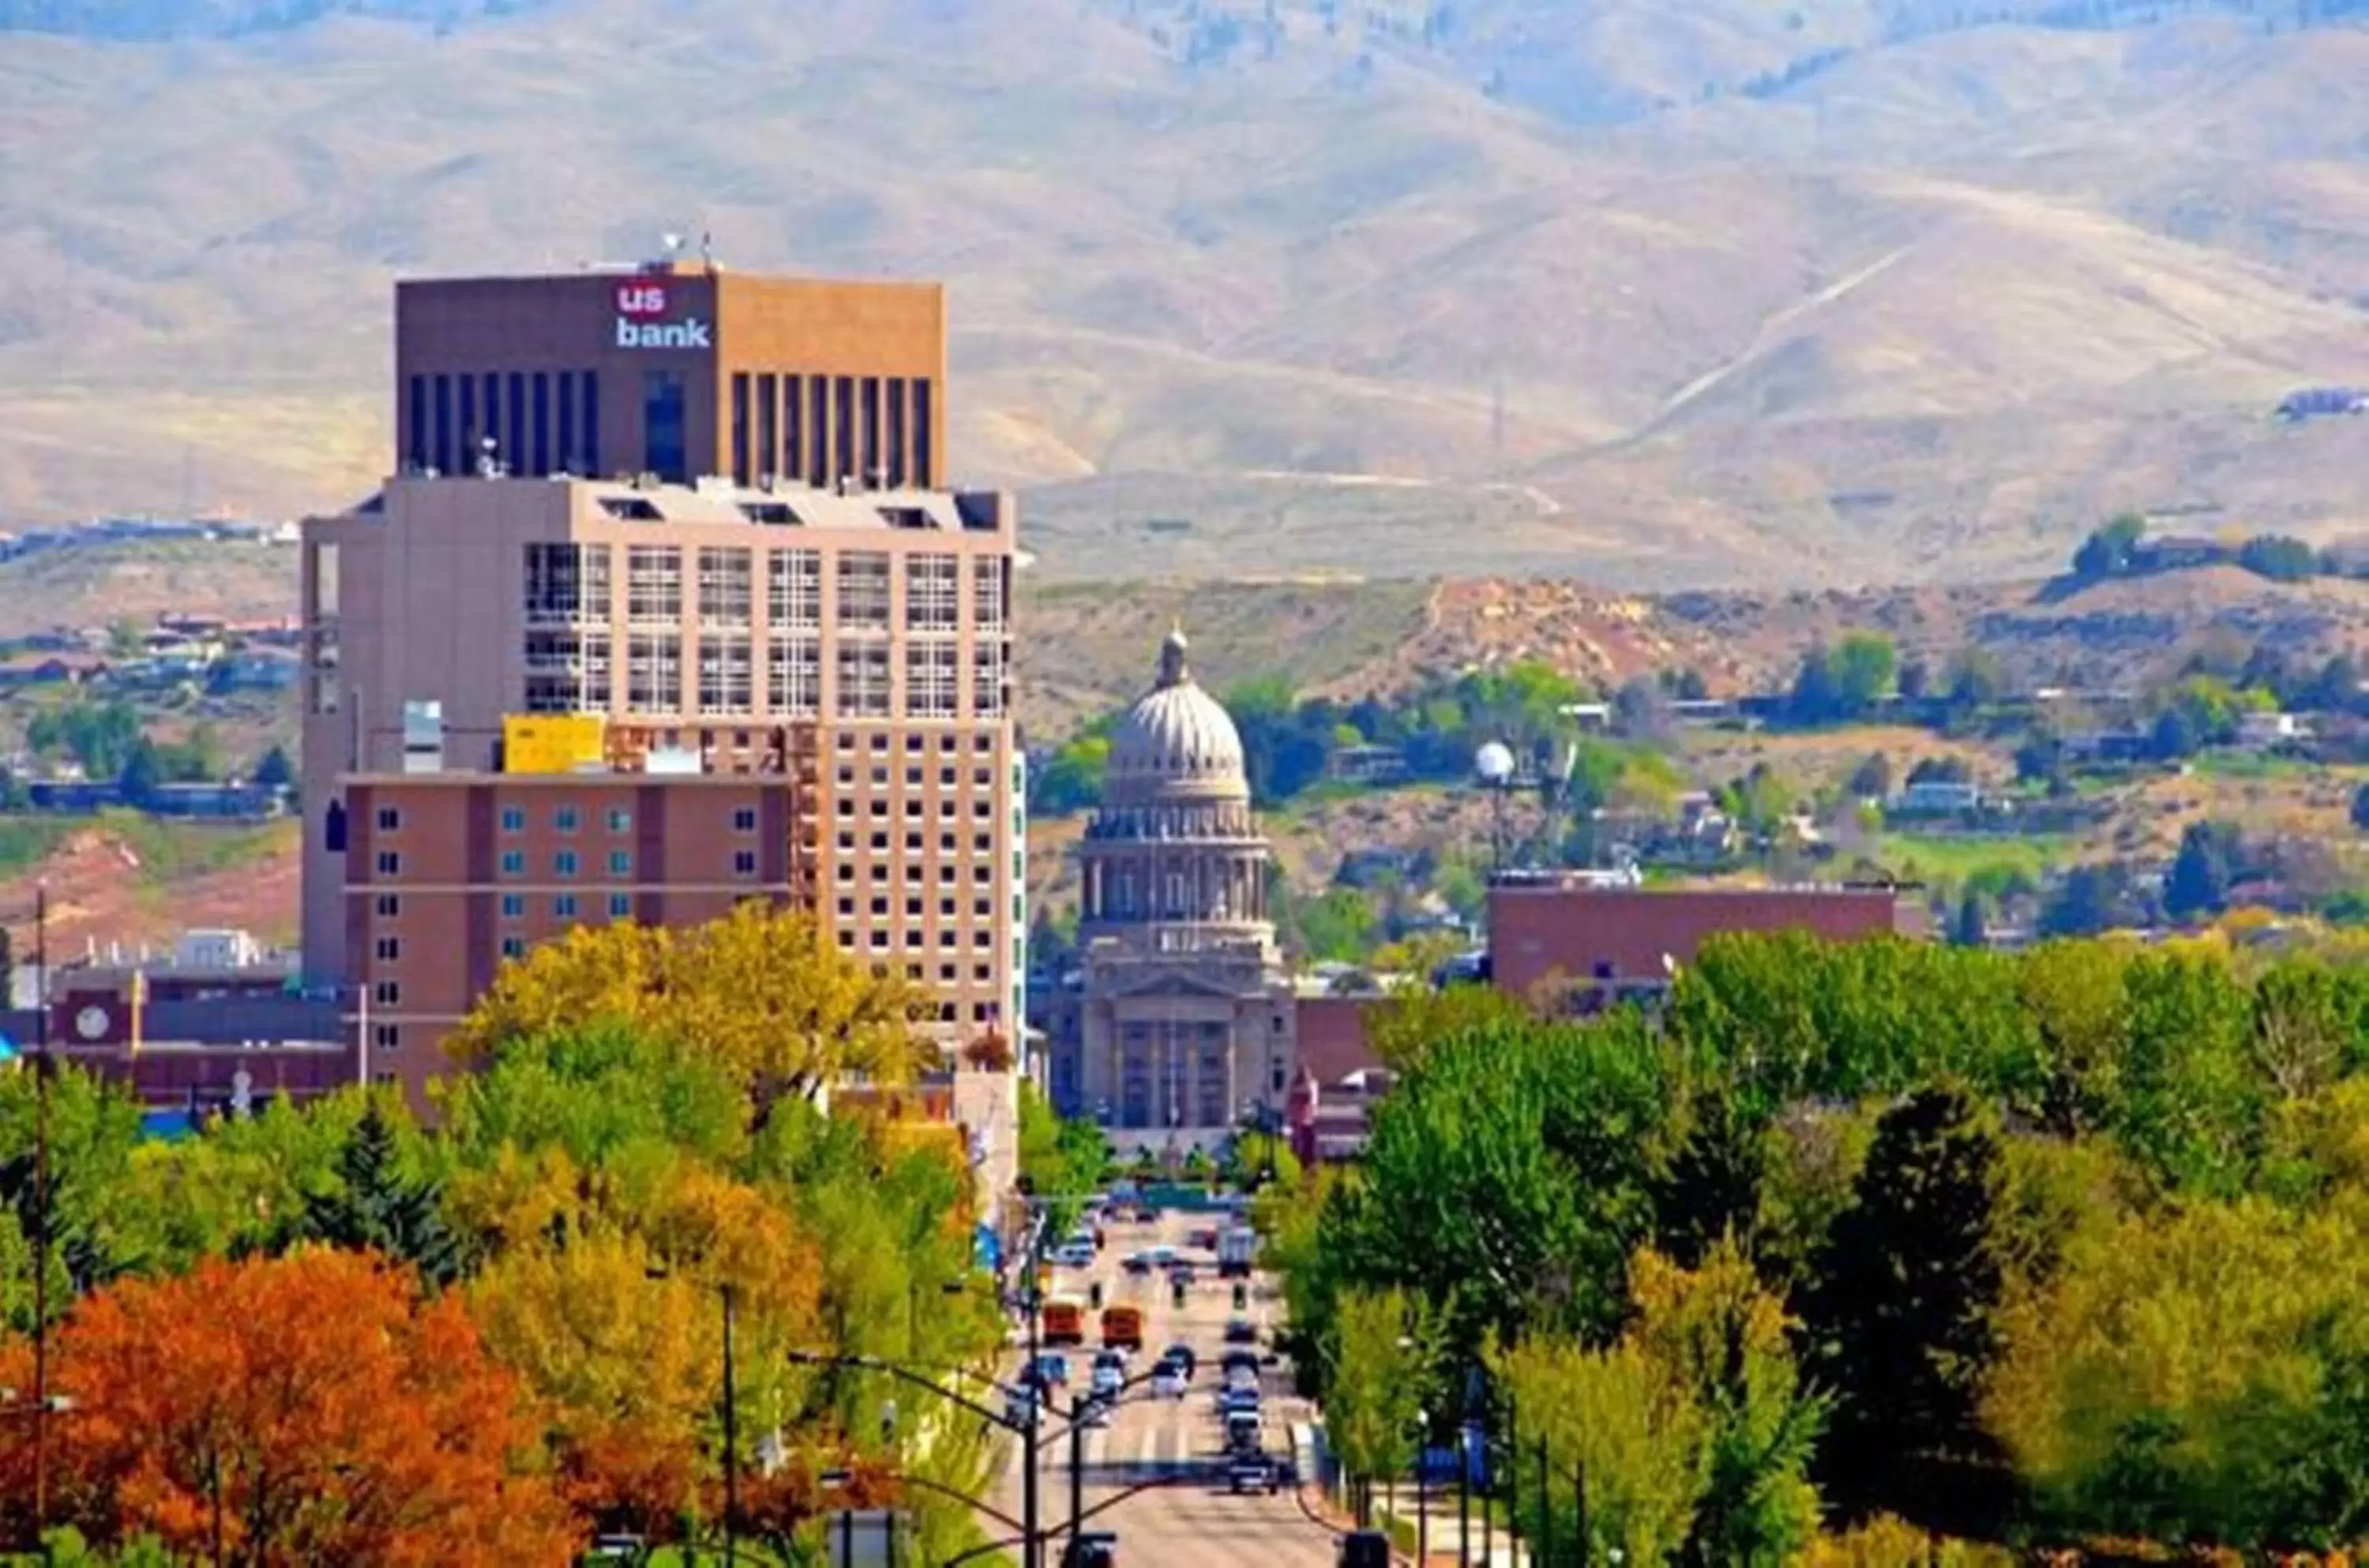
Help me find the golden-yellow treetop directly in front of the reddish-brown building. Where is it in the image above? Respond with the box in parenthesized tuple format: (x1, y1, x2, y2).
(450, 902, 926, 1116)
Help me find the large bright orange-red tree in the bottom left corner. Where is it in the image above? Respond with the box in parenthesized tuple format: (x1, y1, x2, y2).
(0, 1248, 578, 1568)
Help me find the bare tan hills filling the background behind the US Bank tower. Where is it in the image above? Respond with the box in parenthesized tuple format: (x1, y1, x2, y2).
(0, 0, 2369, 587)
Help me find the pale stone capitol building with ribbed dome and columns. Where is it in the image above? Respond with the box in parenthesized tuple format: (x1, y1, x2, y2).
(1042, 630, 1293, 1149)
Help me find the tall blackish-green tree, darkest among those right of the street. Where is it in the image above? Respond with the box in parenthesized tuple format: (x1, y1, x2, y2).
(1803, 1090, 2004, 1528)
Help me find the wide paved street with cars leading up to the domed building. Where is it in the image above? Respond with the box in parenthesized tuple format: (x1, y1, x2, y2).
(995, 1213, 1334, 1568)
